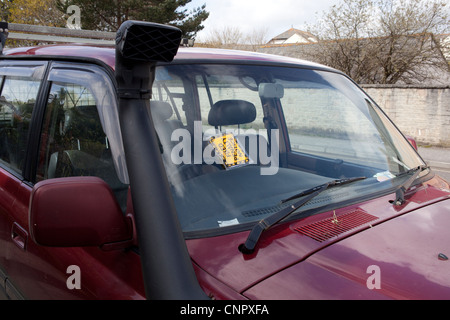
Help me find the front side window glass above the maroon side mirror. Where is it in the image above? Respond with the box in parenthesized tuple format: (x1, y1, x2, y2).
(37, 69, 128, 210)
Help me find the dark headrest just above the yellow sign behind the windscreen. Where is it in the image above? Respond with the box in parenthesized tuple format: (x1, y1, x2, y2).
(208, 100, 256, 127)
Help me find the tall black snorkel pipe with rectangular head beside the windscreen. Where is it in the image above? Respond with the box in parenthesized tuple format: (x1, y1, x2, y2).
(115, 21, 208, 300)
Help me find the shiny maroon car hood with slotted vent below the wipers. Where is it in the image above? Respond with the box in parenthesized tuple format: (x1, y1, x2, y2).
(188, 181, 450, 299)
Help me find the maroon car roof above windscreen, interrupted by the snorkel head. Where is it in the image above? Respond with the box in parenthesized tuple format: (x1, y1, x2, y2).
(4, 44, 335, 71)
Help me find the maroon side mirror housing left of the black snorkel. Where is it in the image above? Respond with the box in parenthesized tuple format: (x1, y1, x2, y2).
(29, 177, 133, 249)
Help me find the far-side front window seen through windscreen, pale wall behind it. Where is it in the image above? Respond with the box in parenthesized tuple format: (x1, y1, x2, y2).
(279, 81, 385, 163)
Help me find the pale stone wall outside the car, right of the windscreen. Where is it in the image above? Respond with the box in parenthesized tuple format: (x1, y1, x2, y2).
(361, 85, 450, 147)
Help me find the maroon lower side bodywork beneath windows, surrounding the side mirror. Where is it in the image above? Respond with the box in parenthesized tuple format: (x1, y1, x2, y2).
(0, 169, 145, 299)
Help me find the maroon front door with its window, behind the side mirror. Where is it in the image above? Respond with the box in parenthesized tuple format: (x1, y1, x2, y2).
(0, 63, 143, 299)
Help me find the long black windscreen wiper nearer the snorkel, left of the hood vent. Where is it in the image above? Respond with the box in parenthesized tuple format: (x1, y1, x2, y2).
(239, 177, 366, 254)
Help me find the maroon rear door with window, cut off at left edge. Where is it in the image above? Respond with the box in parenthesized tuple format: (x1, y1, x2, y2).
(0, 60, 47, 298)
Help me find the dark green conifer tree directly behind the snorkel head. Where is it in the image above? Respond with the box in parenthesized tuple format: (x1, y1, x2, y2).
(59, 0, 209, 38)
